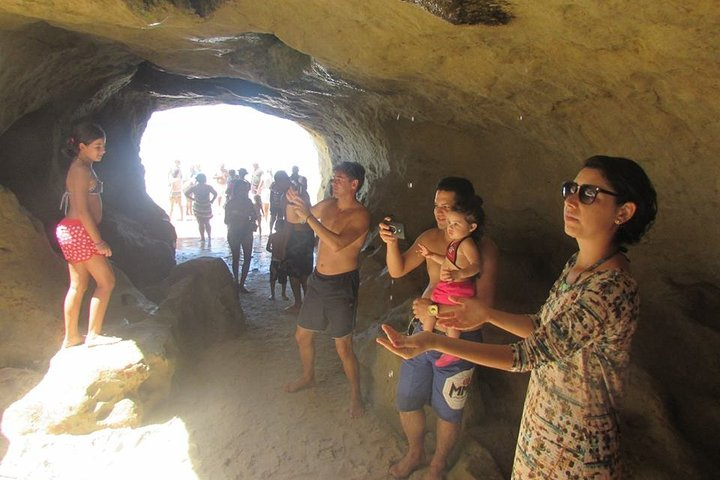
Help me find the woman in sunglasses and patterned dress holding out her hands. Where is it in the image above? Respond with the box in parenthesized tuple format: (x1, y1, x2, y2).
(378, 156, 657, 479)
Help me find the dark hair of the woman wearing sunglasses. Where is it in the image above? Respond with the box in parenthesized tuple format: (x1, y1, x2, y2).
(584, 155, 657, 245)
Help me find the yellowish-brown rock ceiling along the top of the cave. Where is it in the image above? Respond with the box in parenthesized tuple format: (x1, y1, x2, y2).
(0, 0, 720, 140)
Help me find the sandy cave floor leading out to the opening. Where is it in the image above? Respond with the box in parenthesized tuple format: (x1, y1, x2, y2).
(147, 218, 414, 479)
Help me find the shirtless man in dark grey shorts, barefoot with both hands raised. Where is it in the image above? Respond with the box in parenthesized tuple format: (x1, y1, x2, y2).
(285, 162, 370, 418)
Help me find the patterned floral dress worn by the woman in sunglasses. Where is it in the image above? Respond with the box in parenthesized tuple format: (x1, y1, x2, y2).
(511, 254, 640, 479)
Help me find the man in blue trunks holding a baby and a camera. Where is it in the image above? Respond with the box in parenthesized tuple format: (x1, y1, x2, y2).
(380, 177, 498, 480)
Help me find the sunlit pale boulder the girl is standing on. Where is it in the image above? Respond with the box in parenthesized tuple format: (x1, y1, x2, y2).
(2, 321, 174, 441)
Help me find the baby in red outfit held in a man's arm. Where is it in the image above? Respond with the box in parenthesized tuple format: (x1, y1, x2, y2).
(418, 195, 485, 367)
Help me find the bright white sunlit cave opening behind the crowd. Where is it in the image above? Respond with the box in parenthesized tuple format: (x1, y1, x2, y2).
(140, 104, 323, 248)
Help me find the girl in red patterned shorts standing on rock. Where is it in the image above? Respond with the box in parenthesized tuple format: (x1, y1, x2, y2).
(55, 123, 120, 348)
